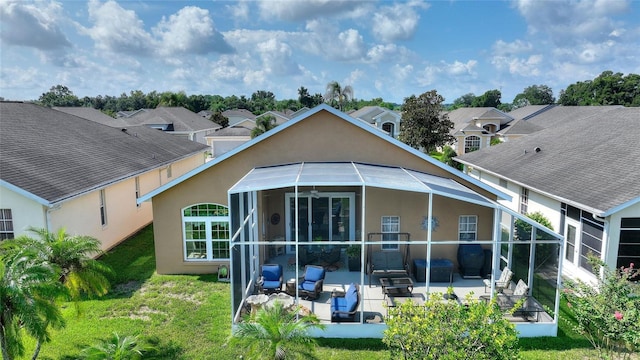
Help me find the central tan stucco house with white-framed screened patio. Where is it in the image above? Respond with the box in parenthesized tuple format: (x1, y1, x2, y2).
(138, 104, 562, 337)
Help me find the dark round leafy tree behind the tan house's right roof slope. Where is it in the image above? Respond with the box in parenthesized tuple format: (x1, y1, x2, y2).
(399, 90, 455, 152)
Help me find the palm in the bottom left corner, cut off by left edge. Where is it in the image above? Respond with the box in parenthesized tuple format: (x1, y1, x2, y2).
(0, 248, 65, 360)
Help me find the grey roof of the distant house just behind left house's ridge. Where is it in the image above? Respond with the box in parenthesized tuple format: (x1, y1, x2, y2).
(123, 106, 221, 132)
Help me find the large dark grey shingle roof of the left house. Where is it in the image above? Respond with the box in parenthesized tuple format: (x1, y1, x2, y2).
(0, 102, 208, 203)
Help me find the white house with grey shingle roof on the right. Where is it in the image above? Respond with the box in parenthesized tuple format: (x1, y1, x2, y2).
(456, 106, 640, 280)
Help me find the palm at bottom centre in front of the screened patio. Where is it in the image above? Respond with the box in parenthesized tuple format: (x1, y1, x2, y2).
(232, 301, 325, 360)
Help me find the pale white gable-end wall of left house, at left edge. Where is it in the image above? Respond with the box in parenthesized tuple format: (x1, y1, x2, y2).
(0, 185, 47, 237)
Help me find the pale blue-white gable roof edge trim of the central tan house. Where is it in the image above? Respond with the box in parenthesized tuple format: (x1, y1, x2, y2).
(138, 104, 511, 202)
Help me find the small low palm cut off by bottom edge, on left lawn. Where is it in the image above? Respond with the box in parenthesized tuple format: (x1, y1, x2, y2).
(82, 332, 150, 360)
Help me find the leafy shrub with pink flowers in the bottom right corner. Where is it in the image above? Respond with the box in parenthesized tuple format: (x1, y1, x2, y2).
(562, 257, 640, 359)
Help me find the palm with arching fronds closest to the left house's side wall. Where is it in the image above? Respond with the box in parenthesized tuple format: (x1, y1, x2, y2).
(3, 227, 113, 303)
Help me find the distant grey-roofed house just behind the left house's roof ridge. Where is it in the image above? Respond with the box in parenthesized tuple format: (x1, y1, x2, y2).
(121, 106, 222, 144)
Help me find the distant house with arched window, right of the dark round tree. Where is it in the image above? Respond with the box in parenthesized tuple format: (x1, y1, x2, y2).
(448, 107, 513, 155)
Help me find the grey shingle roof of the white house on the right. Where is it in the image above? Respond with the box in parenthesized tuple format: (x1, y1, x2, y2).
(455, 106, 640, 216)
